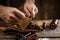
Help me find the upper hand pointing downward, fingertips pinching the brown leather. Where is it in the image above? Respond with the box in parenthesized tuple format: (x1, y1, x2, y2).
(24, 2, 38, 17)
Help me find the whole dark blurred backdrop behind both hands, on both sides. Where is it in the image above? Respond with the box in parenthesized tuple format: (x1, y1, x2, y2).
(0, 0, 60, 19)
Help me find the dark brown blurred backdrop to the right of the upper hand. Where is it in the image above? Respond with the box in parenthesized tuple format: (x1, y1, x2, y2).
(35, 0, 60, 19)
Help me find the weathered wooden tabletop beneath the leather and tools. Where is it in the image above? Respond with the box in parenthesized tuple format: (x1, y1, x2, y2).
(0, 20, 60, 40)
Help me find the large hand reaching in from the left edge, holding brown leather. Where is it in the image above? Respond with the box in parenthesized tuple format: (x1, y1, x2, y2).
(0, 6, 25, 23)
